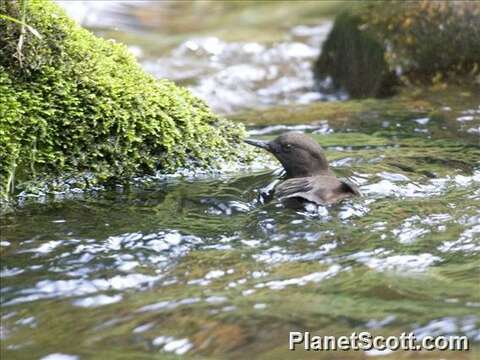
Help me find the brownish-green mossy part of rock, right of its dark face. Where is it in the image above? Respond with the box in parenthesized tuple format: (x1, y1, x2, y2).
(360, 0, 480, 82)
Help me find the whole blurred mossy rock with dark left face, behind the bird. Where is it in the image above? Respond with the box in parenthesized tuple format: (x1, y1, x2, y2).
(314, 0, 480, 98)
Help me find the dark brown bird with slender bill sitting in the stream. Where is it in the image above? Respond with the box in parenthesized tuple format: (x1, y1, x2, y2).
(245, 132, 360, 205)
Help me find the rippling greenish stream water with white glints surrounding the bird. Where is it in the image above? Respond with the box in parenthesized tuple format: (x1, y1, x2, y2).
(0, 1, 480, 360)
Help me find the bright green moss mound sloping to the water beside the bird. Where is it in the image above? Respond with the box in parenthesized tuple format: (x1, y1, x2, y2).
(0, 0, 248, 198)
